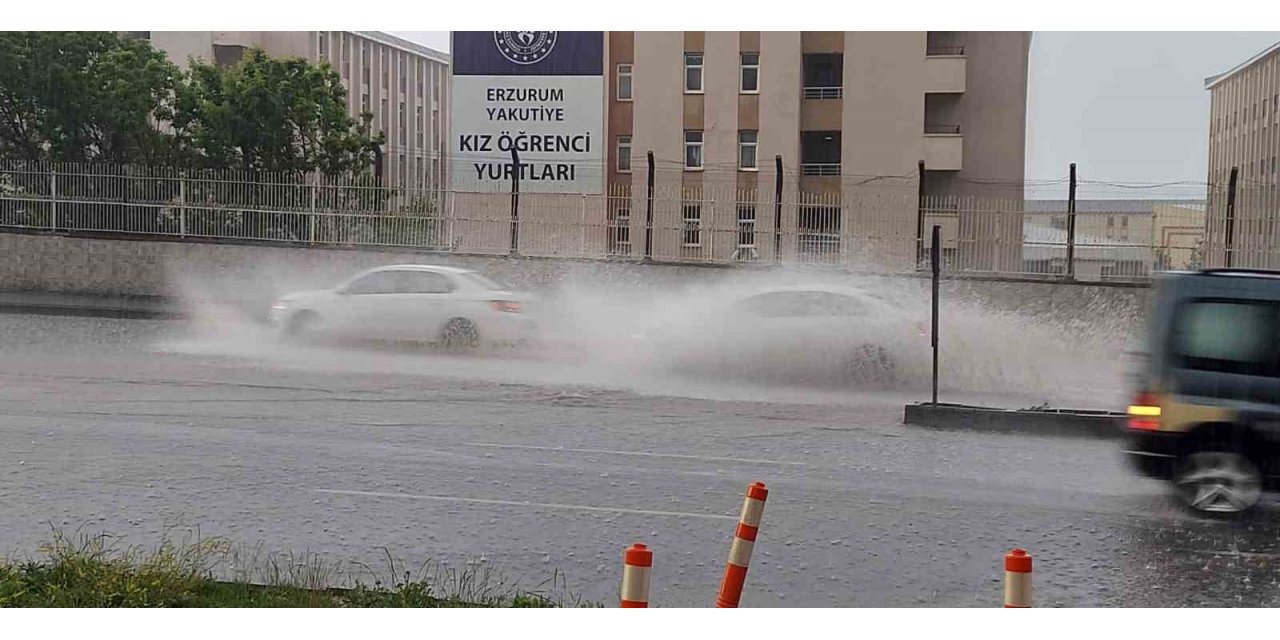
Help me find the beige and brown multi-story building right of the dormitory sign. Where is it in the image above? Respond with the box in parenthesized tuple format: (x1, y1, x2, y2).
(605, 31, 1030, 270)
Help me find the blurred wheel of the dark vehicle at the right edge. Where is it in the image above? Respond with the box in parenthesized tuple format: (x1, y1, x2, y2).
(1174, 451, 1262, 516)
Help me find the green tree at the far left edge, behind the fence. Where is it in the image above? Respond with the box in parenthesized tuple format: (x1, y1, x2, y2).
(0, 31, 180, 164)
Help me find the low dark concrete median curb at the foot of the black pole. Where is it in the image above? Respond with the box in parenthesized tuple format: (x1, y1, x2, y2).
(902, 402, 1124, 439)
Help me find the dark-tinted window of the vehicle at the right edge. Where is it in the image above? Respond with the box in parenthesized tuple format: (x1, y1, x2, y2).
(1172, 300, 1280, 376)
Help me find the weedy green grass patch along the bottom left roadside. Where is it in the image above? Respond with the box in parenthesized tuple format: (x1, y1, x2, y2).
(0, 529, 595, 608)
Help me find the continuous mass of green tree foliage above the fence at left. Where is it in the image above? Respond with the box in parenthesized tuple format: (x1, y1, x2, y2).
(0, 32, 383, 175)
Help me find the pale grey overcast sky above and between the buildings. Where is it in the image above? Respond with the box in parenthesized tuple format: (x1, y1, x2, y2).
(393, 31, 1280, 197)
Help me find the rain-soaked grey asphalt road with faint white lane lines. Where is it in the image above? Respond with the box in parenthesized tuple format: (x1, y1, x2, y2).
(0, 315, 1280, 607)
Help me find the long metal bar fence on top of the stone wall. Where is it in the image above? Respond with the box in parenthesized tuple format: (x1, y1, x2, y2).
(0, 163, 1212, 282)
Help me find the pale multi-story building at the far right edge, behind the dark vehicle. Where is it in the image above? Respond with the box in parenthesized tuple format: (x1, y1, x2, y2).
(1204, 42, 1280, 268)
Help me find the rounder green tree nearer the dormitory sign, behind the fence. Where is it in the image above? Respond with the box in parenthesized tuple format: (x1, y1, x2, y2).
(174, 47, 383, 175)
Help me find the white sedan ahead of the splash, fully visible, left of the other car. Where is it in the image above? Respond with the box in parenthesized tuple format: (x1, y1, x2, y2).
(271, 265, 535, 349)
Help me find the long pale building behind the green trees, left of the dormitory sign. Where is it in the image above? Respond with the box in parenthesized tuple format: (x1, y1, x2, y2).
(125, 31, 449, 188)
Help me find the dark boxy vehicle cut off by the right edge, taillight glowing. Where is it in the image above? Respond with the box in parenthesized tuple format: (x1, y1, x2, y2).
(1125, 270, 1280, 515)
